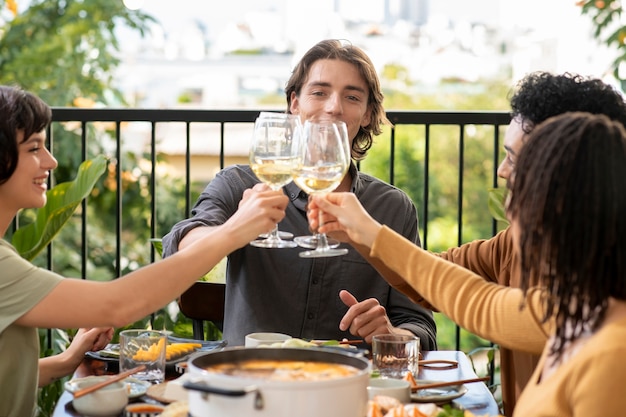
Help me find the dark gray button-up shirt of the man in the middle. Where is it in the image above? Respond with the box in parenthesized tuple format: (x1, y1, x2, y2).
(163, 165, 437, 350)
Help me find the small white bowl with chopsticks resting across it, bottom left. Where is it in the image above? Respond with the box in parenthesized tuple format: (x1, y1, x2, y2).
(65, 376, 128, 417)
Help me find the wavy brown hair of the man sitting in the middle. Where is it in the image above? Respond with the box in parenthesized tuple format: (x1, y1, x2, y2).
(285, 39, 391, 161)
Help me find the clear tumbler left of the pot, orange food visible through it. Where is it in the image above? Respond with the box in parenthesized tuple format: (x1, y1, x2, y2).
(120, 329, 167, 384)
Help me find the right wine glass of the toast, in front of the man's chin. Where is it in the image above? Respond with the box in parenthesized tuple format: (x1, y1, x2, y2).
(293, 120, 350, 258)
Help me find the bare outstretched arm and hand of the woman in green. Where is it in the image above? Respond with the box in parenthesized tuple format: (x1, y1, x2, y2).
(17, 191, 289, 328)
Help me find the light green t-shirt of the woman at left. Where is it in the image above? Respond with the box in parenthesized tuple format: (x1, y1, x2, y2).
(0, 239, 63, 417)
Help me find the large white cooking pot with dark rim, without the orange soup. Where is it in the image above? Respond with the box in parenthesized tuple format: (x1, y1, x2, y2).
(183, 348, 370, 417)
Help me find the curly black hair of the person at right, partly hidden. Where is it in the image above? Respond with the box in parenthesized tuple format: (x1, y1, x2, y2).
(509, 71, 626, 133)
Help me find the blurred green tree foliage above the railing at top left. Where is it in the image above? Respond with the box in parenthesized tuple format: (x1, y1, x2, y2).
(0, 0, 154, 106)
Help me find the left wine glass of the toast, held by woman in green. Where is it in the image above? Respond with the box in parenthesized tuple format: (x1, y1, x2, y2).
(250, 112, 301, 248)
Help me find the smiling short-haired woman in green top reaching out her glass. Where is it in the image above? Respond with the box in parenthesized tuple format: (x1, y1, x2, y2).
(0, 86, 288, 417)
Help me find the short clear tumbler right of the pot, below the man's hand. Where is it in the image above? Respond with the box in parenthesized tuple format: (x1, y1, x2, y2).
(372, 334, 420, 378)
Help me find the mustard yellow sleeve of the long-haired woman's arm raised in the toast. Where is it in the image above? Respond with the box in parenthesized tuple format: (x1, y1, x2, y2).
(370, 227, 552, 354)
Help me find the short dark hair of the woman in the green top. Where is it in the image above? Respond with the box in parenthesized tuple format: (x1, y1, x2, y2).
(0, 85, 52, 184)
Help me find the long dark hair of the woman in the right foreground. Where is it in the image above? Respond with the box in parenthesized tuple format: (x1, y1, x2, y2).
(507, 113, 626, 359)
